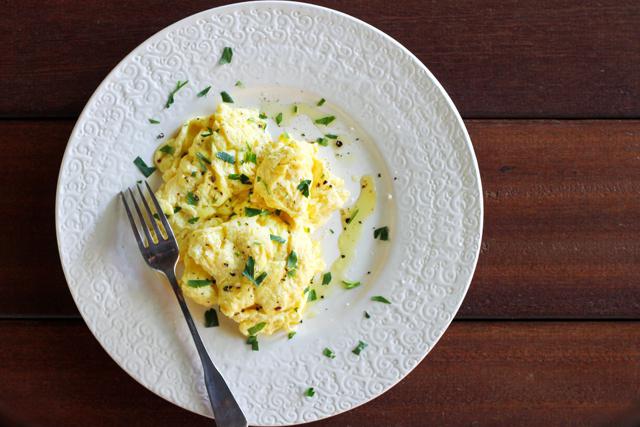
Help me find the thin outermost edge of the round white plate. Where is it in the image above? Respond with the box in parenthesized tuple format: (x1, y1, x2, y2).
(54, 0, 484, 426)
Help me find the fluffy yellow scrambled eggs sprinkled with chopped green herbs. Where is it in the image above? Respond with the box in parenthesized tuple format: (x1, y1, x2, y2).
(154, 104, 348, 335)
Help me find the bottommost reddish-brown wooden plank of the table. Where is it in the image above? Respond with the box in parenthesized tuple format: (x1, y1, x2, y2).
(0, 321, 640, 427)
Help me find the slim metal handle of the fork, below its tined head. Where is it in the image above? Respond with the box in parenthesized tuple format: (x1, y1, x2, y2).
(164, 270, 247, 427)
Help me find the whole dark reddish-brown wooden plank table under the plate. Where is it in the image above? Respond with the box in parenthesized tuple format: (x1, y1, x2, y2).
(0, 0, 640, 427)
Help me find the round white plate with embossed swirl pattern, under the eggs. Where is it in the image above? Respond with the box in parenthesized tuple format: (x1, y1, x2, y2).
(56, 2, 482, 425)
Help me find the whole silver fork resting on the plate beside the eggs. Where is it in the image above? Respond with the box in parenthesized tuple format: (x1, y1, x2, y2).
(120, 181, 247, 427)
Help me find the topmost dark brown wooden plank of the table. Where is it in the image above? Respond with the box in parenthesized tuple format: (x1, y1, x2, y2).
(0, 0, 640, 118)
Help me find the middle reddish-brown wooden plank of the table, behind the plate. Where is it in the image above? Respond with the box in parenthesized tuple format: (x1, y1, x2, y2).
(0, 120, 640, 318)
